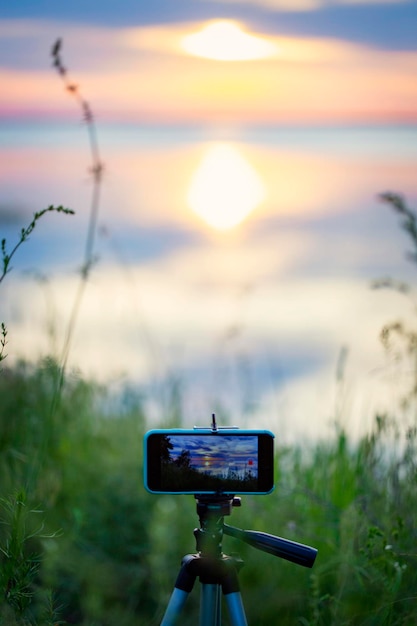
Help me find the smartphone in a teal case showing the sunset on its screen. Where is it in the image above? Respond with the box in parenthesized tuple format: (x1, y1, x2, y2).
(144, 428, 274, 495)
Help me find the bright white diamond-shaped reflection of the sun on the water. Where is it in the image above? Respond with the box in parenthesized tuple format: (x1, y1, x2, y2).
(187, 143, 265, 231)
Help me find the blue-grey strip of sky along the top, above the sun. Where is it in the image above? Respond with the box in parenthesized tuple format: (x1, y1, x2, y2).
(0, 0, 417, 50)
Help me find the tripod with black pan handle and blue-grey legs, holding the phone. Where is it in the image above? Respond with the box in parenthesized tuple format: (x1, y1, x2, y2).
(161, 495, 317, 626)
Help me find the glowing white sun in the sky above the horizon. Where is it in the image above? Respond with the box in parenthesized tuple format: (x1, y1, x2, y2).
(181, 20, 276, 61)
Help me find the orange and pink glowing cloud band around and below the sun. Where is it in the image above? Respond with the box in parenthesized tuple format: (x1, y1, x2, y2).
(0, 18, 417, 123)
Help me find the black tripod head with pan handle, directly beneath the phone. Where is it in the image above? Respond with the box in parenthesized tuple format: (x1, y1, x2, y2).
(194, 495, 317, 567)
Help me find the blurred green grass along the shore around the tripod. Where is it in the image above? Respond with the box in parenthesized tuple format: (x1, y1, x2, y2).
(0, 360, 417, 626)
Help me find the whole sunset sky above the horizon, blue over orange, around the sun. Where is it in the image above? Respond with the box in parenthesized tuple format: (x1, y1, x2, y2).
(0, 0, 417, 124)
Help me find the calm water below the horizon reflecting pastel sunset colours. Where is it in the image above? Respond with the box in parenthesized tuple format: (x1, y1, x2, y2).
(0, 123, 417, 438)
